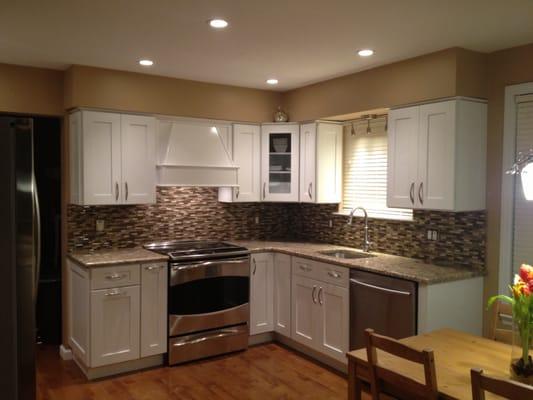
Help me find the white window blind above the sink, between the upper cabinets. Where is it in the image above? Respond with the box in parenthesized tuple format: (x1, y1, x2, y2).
(342, 118, 413, 220)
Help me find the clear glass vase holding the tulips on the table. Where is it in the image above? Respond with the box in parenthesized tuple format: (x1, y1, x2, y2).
(510, 311, 533, 385)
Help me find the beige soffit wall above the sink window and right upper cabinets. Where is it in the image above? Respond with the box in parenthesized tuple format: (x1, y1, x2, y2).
(283, 48, 485, 121)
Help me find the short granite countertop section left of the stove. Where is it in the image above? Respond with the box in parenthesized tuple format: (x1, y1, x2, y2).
(68, 247, 168, 267)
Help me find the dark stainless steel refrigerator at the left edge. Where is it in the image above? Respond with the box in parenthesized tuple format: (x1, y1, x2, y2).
(0, 116, 40, 400)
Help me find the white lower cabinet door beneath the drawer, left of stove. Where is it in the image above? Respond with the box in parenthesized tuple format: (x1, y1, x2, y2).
(90, 286, 141, 367)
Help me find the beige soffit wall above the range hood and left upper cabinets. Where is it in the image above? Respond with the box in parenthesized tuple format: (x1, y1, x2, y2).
(65, 66, 281, 122)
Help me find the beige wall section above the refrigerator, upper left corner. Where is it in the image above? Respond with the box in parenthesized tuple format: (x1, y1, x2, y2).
(0, 64, 63, 115)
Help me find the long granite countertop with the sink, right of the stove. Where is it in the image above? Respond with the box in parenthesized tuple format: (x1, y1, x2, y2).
(228, 241, 485, 285)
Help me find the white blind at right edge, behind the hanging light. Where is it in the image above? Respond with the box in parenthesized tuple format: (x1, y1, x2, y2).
(513, 95, 533, 271)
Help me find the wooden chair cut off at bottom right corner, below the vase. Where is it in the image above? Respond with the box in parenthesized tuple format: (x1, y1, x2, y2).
(470, 368, 533, 400)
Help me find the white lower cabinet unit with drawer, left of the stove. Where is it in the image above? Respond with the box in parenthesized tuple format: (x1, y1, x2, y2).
(68, 260, 167, 378)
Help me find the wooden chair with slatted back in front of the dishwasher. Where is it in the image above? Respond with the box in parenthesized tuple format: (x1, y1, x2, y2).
(365, 329, 439, 400)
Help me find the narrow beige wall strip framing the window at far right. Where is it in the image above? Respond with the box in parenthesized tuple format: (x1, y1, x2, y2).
(485, 44, 533, 334)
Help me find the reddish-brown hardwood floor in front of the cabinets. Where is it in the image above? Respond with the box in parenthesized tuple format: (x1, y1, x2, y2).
(37, 343, 354, 400)
